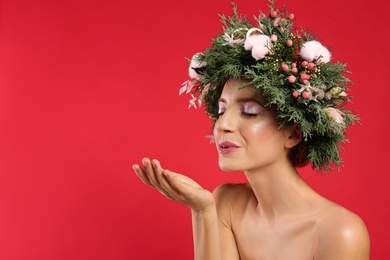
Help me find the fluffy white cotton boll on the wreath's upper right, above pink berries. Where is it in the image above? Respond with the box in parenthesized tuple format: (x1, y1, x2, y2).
(300, 41, 331, 63)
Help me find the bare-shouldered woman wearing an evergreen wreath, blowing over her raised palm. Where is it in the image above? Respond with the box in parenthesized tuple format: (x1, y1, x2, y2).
(133, 2, 369, 260)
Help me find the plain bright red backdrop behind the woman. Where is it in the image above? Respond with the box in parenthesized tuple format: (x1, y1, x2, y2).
(0, 0, 390, 259)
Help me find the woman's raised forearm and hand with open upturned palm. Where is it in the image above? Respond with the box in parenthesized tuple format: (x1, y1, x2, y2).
(133, 158, 222, 260)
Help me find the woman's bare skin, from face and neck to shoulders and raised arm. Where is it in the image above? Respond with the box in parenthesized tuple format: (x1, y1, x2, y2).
(133, 80, 370, 260)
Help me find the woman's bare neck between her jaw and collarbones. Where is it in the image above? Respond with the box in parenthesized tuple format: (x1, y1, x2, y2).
(245, 164, 317, 220)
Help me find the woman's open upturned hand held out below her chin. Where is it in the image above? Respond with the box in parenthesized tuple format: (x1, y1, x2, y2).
(133, 158, 215, 212)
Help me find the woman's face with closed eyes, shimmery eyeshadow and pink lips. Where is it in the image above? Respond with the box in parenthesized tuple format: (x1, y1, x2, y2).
(214, 80, 288, 172)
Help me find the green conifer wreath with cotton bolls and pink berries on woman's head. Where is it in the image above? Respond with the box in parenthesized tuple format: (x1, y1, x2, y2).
(179, 0, 358, 172)
